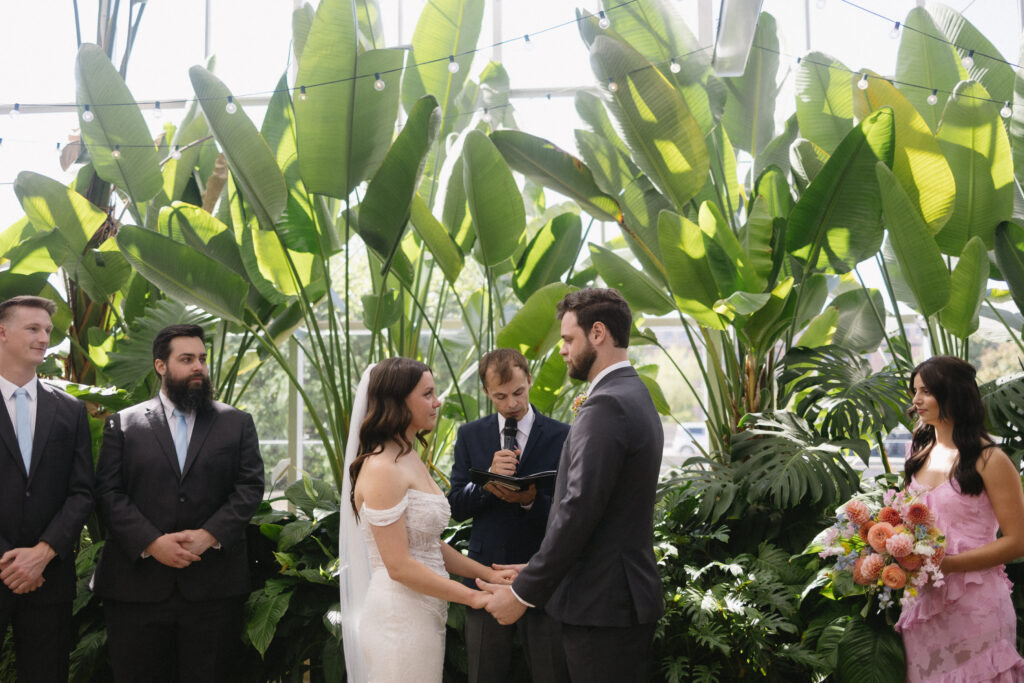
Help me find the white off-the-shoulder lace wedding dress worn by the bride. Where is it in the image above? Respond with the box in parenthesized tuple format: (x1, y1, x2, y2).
(358, 488, 452, 683)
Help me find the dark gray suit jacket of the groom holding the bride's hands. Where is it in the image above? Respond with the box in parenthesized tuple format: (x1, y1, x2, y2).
(512, 368, 665, 627)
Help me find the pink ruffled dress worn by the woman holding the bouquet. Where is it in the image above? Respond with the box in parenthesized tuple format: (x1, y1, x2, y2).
(896, 481, 1024, 683)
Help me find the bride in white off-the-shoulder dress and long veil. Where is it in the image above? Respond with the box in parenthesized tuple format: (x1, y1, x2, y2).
(340, 357, 515, 683)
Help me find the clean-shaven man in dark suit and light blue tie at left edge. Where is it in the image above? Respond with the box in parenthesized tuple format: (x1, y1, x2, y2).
(0, 296, 92, 683)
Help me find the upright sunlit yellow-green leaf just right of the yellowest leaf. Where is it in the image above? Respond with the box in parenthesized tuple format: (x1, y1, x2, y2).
(936, 81, 1014, 256)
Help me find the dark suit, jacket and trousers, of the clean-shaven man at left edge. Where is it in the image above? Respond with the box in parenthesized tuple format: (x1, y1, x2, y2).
(0, 382, 93, 681)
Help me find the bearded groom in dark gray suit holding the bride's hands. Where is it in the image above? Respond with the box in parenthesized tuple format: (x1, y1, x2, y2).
(478, 289, 665, 683)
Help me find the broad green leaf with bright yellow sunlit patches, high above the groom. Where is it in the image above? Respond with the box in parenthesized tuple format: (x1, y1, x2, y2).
(590, 36, 710, 210)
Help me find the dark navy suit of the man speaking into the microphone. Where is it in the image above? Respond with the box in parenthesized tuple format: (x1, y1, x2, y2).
(447, 408, 569, 683)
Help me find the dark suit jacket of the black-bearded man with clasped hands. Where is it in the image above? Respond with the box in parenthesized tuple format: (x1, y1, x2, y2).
(95, 396, 263, 602)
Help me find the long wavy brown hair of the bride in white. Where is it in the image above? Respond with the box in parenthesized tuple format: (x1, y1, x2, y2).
(348, 356, 430, 514)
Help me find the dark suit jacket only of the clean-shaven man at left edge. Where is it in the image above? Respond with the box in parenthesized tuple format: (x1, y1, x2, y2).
(0, 382, 92, 603)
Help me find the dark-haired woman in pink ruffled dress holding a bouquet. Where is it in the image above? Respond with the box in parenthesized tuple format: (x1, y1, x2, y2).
(896, 356, 1024, 683)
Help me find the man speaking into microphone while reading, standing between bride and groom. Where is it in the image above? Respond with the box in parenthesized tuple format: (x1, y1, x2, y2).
(447, 348, 569, 683)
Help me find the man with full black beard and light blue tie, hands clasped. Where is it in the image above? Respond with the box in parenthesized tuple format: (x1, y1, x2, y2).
(95, 325, 263, 683)
